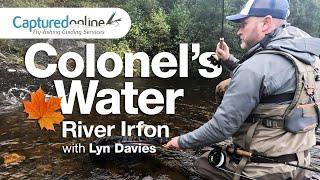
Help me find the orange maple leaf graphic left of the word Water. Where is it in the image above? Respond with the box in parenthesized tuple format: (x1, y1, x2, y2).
(23, 87, 64, 130)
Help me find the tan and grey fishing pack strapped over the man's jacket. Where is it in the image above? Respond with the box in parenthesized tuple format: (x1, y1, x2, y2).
(248, 50, 320, 133)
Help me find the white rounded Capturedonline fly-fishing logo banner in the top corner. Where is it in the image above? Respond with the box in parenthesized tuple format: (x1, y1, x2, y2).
(0, 8, 131, 39)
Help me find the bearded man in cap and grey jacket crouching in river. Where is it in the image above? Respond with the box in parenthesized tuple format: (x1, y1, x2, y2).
(165, 0, 320, 179)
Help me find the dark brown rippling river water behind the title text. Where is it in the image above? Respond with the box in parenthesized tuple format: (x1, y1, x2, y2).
(0, 60, 320, 180)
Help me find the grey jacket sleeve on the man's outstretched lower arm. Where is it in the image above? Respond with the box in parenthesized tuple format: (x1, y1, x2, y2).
(178, 65, 264, 148)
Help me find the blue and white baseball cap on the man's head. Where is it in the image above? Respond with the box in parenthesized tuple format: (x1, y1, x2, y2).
(226, 0, 290, 23)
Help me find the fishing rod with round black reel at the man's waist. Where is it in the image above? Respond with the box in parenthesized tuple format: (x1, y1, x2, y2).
(208, 145, 320, 173)
